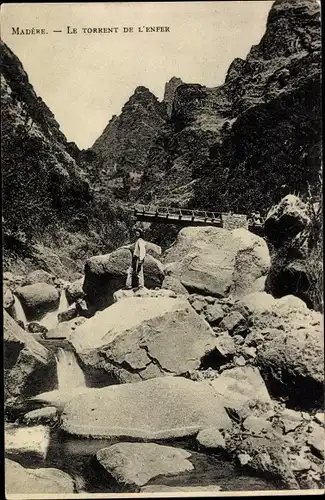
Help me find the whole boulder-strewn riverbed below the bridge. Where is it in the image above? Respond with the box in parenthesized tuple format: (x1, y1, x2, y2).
(4, 217, 325, 494)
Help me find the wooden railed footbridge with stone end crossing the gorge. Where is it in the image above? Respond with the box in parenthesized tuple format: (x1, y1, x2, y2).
(133, 205, 264, 233)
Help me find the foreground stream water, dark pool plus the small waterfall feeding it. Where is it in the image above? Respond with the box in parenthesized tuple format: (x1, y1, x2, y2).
(5, 324, 277, 493)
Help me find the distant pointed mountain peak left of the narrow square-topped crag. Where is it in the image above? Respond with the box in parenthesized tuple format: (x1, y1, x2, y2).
(92, 86, 167, 198)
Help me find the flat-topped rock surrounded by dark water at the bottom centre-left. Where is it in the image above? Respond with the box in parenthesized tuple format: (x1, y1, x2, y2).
(96, 443, 194, 488)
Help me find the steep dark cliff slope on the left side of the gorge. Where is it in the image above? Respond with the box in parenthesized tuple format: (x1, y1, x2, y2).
(0, 43, 127, 278)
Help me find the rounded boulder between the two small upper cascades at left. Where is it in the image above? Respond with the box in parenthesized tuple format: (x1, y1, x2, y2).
(15, 283, 60, 320)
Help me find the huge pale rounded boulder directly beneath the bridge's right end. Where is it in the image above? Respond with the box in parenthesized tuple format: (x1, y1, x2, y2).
(164, 226, 270, 297)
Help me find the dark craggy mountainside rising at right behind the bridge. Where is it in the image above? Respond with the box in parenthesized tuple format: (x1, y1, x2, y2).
(141, 0, 321, 213)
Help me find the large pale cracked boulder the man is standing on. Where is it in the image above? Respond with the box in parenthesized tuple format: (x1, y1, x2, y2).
(70, 290, 223, 382)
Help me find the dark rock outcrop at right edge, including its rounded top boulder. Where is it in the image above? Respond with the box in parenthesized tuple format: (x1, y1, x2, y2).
(264, 195, 323, 312)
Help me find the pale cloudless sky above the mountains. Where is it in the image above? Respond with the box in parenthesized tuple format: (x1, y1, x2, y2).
(1, 0, 273, 149)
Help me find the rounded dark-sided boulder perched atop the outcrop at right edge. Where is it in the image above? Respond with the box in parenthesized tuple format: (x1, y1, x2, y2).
(264, 194, 310, 246)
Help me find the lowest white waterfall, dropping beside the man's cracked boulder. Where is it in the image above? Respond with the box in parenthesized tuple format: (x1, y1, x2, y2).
(55, 347, 87, 391)
